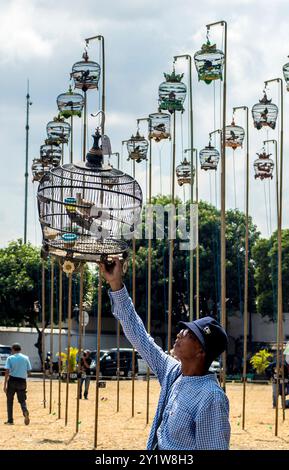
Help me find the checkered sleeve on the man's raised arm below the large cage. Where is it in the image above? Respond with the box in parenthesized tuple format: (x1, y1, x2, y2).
(109, 286, 178, 384)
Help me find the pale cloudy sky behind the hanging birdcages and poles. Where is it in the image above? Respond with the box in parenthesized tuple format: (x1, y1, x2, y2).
(0, 0, 289, 246)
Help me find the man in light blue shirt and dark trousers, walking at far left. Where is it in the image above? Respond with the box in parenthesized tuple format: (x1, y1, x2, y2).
(4, 343, 31, 425)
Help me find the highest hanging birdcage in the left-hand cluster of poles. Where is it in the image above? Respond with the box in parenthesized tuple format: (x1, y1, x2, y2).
(71, 50, 100, 92)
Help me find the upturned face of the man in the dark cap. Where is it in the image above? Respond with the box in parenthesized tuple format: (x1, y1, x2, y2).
(174, 329, 205, 361)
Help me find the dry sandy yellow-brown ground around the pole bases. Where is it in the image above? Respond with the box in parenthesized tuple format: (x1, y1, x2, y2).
(0, 379, 289, 450)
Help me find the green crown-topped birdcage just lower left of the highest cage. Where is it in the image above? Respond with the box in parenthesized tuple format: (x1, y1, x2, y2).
(159, 69, 187, 114)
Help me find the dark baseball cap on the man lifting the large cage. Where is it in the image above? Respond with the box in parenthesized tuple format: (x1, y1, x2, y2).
(179, 317, 228, 362)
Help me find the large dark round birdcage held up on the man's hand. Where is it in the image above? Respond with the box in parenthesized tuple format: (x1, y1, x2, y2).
(37, 130, 142, 262)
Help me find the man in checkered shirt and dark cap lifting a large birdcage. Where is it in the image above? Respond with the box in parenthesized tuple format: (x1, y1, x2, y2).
(101, 258, 230, 450)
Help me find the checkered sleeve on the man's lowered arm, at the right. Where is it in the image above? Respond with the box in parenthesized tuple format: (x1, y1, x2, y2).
(196, 396, 231, 450)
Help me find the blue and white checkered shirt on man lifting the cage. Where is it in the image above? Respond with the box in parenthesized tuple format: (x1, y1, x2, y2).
(109, 287, 230, 450)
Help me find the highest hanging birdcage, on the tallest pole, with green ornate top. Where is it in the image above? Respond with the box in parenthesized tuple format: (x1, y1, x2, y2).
(194, 39, 225, 84)
